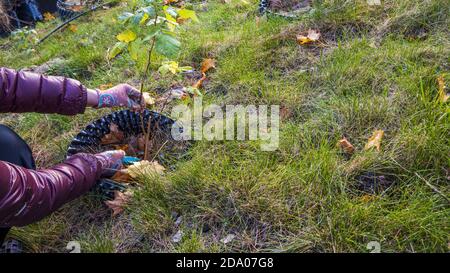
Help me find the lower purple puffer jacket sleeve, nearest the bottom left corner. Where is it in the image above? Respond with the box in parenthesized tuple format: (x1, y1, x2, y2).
(0, 154, 106, 227)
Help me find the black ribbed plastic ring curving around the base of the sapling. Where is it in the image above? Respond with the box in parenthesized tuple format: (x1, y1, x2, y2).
(67, 110, 182, 156)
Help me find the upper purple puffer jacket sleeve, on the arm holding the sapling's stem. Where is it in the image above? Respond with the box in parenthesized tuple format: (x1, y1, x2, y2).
(0, 68, 87, 115)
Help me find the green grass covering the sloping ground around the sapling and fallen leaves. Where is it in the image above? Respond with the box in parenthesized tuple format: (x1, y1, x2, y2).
(0, 0, 450, 252)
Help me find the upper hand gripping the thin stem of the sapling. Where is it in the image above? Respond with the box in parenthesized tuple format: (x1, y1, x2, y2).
(88, 84, 145, 110)
